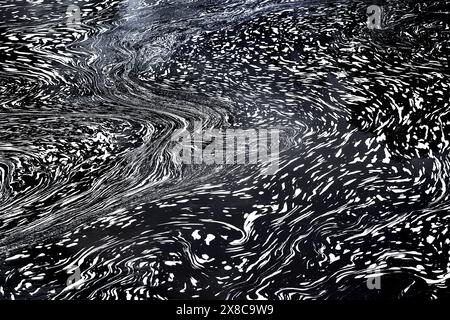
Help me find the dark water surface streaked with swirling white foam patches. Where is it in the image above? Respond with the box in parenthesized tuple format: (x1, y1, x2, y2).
(0, 0, 450, 299)
